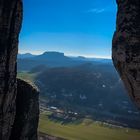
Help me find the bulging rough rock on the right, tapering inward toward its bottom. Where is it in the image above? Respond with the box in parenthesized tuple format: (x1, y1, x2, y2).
(112, 0, 140, 108)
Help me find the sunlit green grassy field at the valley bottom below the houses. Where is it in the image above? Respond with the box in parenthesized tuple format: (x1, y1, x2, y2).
(39, 114, 140, 140)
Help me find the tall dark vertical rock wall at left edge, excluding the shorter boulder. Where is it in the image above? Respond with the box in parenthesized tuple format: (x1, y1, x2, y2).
(0, 0, 22, 140)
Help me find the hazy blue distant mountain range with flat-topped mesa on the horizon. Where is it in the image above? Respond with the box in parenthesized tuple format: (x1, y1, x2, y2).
(18, 52, 111, 71)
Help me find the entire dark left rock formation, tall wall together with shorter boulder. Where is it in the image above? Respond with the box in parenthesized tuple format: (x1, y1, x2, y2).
(0, 0, 39, 140)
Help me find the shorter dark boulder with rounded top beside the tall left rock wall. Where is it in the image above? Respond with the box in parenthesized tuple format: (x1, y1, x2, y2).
(11, 79, 39, 140)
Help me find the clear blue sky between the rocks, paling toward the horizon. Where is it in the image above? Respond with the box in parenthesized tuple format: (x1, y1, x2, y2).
(19, 0, 116, 57)
